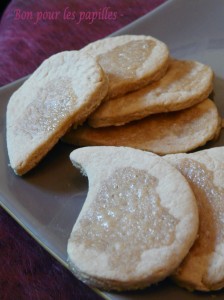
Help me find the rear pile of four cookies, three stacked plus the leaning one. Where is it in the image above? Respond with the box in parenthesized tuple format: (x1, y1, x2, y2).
(7, 35, 221, 175)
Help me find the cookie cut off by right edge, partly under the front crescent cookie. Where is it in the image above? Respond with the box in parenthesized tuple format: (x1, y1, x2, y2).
(166, 147, 224, 291)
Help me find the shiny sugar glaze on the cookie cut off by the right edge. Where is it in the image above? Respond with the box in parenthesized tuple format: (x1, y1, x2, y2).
(177, 158, 224, 255)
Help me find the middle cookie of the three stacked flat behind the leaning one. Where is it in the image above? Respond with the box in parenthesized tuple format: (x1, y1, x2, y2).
(89, 60, 213, 127)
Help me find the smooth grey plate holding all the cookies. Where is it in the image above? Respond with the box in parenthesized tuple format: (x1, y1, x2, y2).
(0, 0, 224, 300)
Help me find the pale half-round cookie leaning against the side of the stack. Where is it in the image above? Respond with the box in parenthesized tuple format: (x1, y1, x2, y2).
(7, 51, 108, 175)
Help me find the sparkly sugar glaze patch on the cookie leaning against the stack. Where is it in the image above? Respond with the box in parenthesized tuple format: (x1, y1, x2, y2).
(16, 79, 77, 139)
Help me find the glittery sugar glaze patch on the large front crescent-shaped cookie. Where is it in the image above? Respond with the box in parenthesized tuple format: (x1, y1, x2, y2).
(73, 167, 178, 274)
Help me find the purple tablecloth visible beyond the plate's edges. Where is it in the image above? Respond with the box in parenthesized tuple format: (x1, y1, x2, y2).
(0, 0, 164, 300)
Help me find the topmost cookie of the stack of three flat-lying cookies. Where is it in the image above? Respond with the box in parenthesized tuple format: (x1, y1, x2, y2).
(81, 35, 169, 99)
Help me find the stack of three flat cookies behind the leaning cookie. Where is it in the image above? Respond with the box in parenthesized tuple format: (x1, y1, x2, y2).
(63, 36, 221, 155)
